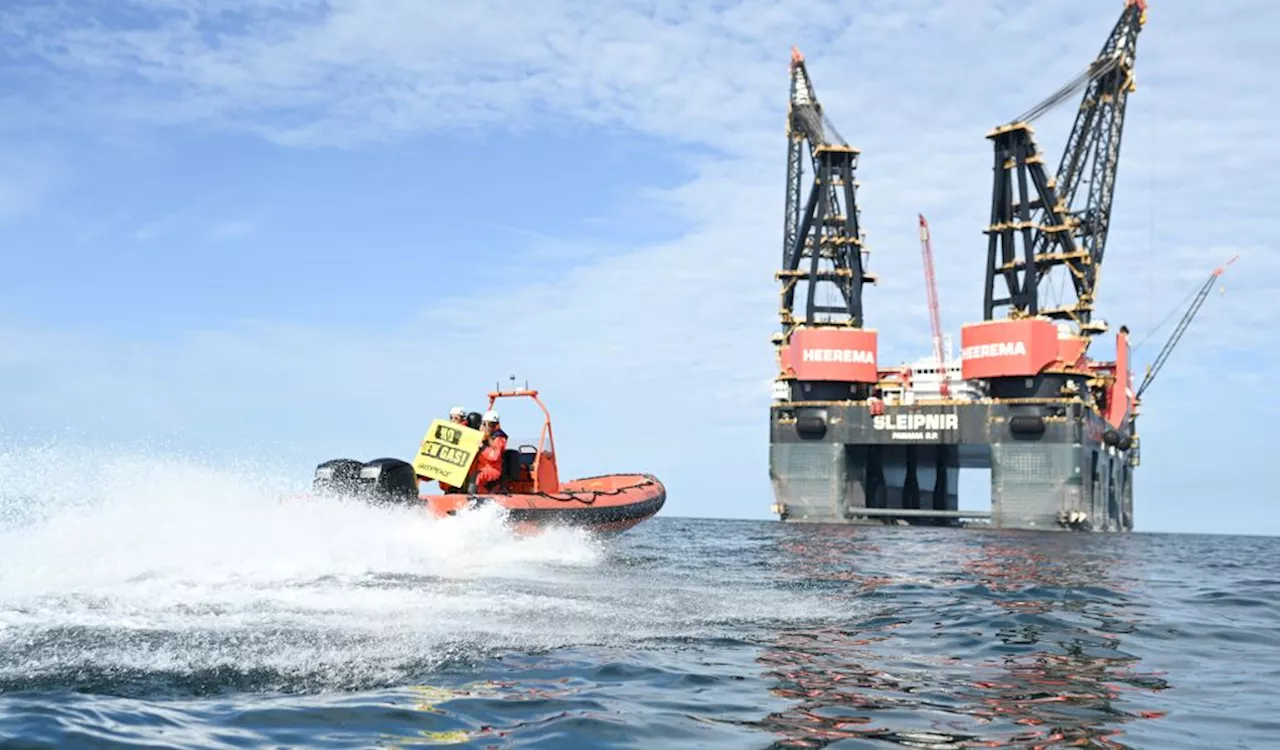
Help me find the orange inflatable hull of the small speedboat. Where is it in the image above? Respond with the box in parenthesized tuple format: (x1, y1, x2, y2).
(420, 474, 667, 534)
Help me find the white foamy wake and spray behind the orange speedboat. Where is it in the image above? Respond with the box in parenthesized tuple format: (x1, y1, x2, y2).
(0, 440, 605, 692)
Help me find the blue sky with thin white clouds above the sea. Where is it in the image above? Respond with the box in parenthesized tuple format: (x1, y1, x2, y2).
(0, 0, 1280, 534)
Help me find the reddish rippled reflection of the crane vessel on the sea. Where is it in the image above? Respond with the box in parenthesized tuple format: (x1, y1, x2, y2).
(758, 527, 1169, 749)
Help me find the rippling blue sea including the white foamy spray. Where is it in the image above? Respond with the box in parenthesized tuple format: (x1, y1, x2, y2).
(0, 451, 1280, 749)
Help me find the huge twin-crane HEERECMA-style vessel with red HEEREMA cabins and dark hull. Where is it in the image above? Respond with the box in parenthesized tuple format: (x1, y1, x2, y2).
(769, 0, 1234, 531)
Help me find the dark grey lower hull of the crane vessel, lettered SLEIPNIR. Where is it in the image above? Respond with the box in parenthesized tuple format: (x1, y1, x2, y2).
(769, 399, 1138, 531)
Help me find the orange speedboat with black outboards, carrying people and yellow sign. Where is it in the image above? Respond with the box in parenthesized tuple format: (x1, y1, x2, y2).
(312, 388, 667, 534)
